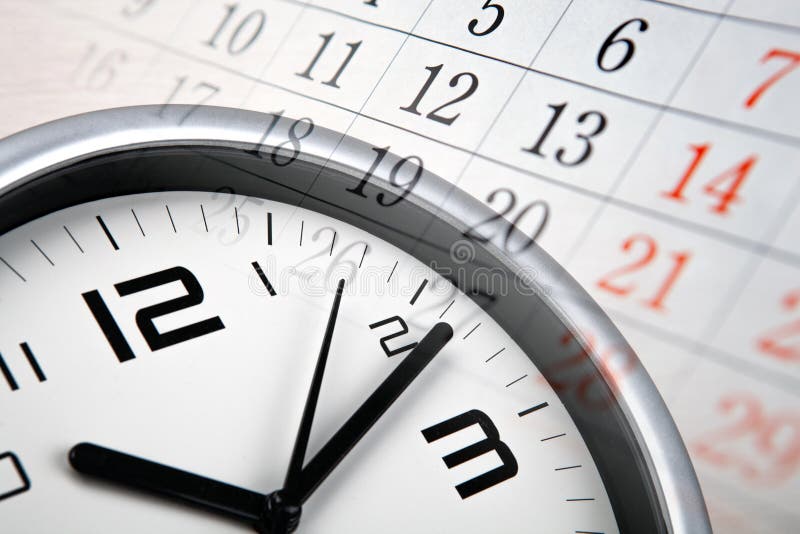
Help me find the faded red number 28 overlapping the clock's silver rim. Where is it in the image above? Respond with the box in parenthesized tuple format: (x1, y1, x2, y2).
(542, 331, 638, 410)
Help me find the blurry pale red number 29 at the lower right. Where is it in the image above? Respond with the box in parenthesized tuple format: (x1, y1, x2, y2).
(692, 394, 800, 484)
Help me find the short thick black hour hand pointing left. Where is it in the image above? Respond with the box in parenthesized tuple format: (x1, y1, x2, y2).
(69, 443, 267, 525)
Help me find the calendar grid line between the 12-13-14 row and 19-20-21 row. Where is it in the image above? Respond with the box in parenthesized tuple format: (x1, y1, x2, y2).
(45, 7, 800, 276)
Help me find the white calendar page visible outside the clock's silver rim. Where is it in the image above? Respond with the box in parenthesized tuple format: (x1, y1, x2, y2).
(0, 0, 800, 533)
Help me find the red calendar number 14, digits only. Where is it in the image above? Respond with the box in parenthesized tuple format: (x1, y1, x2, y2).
(661, 143, 758, 215)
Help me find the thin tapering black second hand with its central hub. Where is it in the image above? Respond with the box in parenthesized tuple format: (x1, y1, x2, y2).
(262, 279, 345, 534)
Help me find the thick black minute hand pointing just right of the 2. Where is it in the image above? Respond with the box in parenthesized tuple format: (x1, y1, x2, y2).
(297, 323, 453, 503)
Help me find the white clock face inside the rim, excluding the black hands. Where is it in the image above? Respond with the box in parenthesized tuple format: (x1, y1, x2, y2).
(0, 192, 618, 534)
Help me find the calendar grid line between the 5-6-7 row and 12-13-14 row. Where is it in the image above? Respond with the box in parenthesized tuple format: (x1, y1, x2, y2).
(266, 0, 800, 146)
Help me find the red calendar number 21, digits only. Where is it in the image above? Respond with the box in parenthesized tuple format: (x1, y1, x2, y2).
(597, 234, 691, 311)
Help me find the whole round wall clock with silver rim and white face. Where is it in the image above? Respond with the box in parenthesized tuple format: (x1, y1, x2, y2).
(0, 106, 710, 534)
